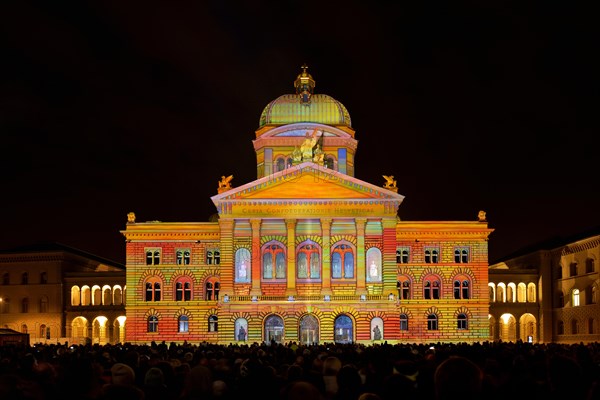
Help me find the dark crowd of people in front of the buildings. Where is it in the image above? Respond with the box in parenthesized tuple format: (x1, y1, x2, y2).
(0, 341, 600, 400)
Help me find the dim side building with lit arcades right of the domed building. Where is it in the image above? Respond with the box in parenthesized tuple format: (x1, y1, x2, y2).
(489, 229, 600, 343)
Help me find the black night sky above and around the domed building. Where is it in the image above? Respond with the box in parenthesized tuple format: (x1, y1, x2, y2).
(0, 0, 600, 262)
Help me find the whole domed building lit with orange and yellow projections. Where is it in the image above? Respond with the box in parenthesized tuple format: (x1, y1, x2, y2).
(122, 67, 492, 344)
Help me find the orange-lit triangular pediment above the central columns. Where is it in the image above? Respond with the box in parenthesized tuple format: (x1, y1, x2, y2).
(212, 162, 404, 218)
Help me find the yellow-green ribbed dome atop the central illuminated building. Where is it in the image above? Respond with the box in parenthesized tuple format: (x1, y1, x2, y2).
(259, 94, 352, 128)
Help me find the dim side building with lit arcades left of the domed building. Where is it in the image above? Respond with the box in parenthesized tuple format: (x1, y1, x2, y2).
(0, 243, 125, 344)
